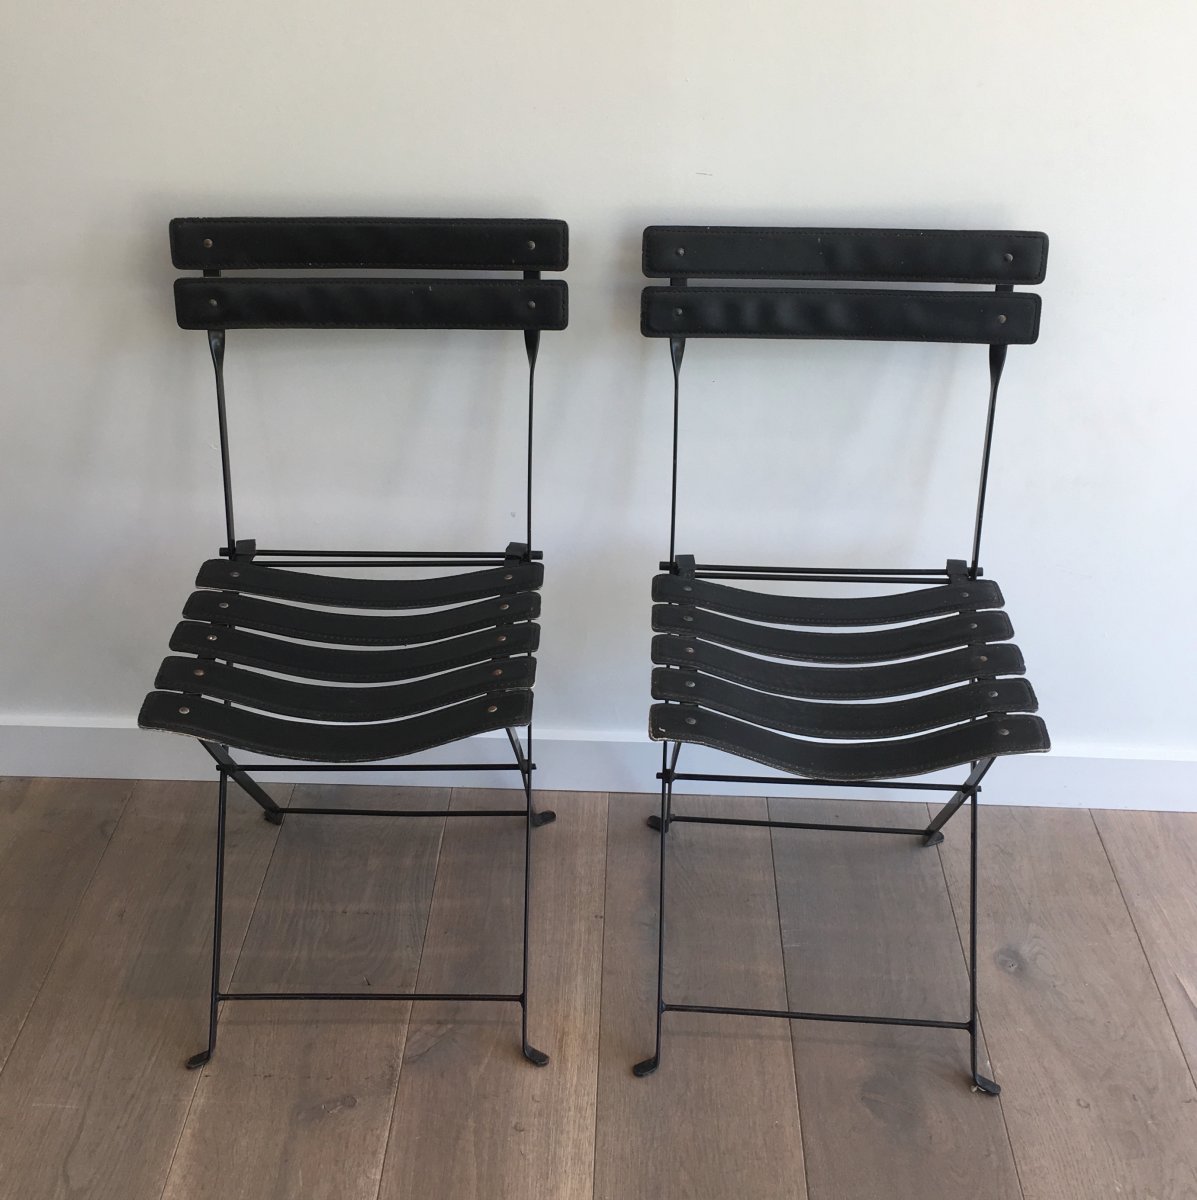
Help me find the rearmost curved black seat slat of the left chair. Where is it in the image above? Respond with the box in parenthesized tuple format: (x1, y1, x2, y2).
(196, 558, 545, 608)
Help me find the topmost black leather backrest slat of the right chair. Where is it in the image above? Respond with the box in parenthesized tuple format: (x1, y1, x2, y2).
(644, 226, 1047, 284)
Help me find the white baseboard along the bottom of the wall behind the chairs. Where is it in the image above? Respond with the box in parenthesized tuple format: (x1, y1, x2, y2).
(0, 719, 1197, 812)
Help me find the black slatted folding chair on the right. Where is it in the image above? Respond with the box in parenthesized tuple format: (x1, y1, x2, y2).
(634, 226, 1049, 1094)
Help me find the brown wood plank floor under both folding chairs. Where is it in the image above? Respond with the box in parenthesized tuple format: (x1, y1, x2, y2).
(0, 780, 1197, 1200)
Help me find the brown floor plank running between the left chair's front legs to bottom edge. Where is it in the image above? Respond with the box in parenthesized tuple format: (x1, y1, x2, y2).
(154, 786, 450, 1200)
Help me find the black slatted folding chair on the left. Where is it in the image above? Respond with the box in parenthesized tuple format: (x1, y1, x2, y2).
(139, 218, 569, 1067)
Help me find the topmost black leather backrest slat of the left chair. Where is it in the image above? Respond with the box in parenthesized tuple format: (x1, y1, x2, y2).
(170, 217, 570, 271)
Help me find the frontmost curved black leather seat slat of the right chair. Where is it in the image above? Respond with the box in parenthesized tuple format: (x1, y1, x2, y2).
(649, 704, 1051, 781)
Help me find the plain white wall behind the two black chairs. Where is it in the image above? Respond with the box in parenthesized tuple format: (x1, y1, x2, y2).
(0, 0, 1197, 804)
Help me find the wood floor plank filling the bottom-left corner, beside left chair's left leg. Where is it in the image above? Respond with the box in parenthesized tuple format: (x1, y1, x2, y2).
(0, 782, 289, 1200)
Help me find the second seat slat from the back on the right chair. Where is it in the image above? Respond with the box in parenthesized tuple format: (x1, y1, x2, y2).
(652, 604, 1013, 662)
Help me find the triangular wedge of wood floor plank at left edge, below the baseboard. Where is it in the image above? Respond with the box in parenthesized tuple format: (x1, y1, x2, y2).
(0, 779, 133, 1070)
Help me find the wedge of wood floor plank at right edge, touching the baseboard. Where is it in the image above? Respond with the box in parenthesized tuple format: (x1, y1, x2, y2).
(1093, 809, 1197, 1076)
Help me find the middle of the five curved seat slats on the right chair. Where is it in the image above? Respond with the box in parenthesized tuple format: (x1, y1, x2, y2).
(652, 634, 1023, 700)
